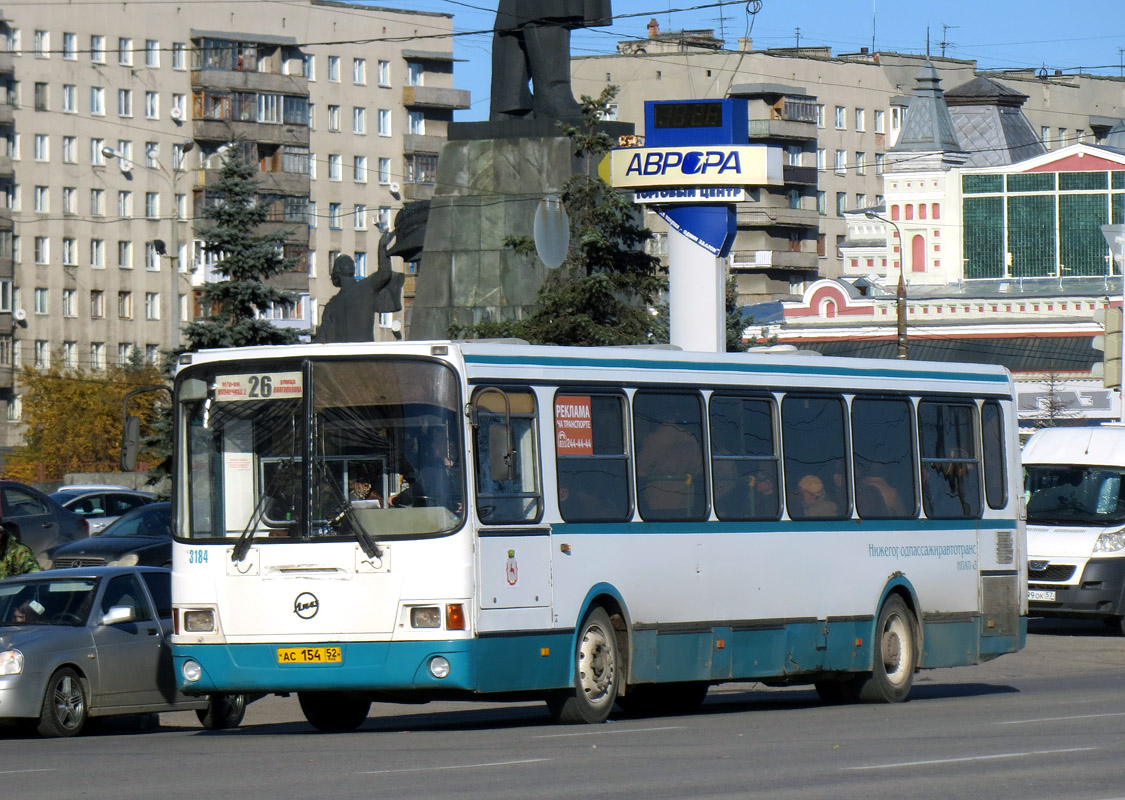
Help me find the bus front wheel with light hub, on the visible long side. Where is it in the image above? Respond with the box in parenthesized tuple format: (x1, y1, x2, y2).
(547, 608, 621, 725)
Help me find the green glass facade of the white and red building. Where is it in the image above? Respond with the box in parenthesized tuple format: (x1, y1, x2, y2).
(961, 170, 1125, 278)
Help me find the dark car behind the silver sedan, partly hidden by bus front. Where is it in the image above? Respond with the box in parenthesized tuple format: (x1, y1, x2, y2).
(51, 503, 172, 569)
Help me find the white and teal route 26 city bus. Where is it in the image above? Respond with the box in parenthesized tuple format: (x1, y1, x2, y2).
(172, 342, 1027, 730)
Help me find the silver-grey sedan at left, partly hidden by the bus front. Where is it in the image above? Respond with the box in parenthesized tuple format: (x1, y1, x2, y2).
(0, 567, 246, 736)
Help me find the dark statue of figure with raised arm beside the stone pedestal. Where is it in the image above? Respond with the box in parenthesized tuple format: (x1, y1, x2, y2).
(314, 231, 405, 342)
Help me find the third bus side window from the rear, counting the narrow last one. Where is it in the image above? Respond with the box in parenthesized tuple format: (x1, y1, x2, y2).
(852, 397, 918, 520)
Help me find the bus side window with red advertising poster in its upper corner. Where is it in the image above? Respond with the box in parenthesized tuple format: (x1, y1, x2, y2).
(555, 392, 632, 522)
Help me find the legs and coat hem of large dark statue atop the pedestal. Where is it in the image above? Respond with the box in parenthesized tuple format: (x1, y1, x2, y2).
(489, 0, 613, 122)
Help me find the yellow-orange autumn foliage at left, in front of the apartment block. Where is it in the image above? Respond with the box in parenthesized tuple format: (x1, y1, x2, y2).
(3, 359, 168, 483)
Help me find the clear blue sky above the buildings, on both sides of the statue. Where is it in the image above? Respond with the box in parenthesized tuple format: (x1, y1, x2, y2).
(369, 0, 1125, 122)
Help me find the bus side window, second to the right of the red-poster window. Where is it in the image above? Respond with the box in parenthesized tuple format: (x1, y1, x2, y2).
(710, 395, 781, 520)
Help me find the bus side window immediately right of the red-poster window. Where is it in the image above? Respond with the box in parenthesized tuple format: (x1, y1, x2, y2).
(633, 392, 708, 521)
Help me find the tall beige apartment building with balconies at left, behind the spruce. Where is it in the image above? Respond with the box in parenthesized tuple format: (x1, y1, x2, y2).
(0, 0, 469, 448)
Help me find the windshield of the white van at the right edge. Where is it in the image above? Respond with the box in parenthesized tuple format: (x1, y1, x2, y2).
(1025, 465, 1125, 525)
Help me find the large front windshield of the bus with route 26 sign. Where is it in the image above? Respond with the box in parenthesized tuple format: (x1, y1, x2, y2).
(177, 358, 465, 541)
